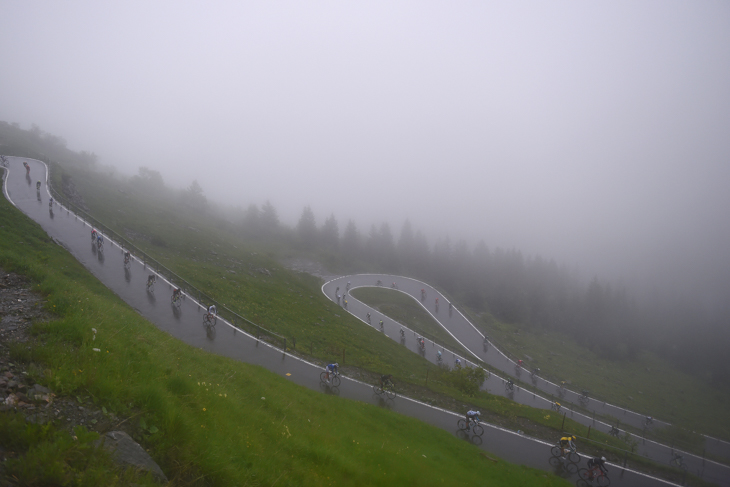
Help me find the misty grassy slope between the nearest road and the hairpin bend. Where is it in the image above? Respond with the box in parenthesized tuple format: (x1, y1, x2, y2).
(48, 164, 724, 485)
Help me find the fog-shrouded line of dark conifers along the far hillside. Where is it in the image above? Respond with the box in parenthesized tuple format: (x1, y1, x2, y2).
(0, 122, 730, 386)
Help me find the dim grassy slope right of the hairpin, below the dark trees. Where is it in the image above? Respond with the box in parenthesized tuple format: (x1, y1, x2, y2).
(466, 315, 730, 454)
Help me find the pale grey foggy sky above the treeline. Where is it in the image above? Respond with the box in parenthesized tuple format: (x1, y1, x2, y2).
(0, 1, 730, 304)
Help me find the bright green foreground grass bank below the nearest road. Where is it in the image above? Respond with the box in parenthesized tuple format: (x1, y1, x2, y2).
(0, 178, 564, 485)
